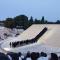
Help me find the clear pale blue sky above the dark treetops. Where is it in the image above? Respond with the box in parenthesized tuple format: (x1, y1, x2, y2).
(0, 0, 60, 21)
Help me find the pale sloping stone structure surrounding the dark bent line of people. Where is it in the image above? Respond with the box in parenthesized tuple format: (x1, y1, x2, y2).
(1, 24, 60, 54)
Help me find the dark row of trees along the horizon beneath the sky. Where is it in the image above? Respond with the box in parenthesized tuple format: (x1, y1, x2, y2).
(0, 15, 60, 29)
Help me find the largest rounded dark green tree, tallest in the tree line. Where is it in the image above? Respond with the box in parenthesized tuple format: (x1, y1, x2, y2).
(14, 15, 28, 29)
